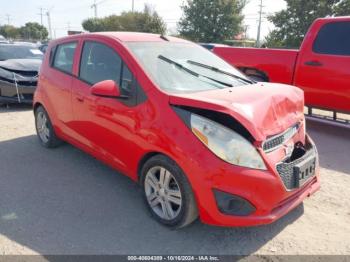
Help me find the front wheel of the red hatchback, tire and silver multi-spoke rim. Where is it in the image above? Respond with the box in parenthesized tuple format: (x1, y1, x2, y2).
(140, 155, 198, 228)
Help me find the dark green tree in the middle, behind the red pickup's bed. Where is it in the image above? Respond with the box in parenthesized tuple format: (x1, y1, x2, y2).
(178, 0, 246, 43)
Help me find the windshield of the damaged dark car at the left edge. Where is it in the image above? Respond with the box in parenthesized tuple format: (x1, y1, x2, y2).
(0, 45, 43, 61)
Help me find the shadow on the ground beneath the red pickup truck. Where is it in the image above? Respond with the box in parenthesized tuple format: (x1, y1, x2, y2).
(306, 120, 350, 174)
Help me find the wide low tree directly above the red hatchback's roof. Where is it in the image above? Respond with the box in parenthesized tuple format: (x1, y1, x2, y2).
(82, 5, 166, 34)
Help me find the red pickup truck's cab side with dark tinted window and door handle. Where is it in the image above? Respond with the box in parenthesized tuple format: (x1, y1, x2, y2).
(295, 21, 350, 112)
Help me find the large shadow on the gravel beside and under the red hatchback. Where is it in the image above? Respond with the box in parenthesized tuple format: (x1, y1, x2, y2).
(0, 136, 304, 255)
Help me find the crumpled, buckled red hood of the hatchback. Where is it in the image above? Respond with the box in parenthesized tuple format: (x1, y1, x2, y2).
(169, 83, 304, 141)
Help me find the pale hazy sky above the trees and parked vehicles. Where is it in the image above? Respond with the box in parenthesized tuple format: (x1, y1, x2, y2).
(0, 0, 286, 38)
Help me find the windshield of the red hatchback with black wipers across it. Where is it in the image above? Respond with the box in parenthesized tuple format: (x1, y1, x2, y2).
(127, 42, 249, 93)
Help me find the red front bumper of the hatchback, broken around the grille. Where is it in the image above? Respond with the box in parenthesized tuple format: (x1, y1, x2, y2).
(185, 135, 320, 226)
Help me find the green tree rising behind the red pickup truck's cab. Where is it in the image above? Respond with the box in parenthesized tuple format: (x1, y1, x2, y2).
(265, 0, 350, 48)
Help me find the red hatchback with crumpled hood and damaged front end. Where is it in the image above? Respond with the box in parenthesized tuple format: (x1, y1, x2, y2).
(34, 33, 320, 228)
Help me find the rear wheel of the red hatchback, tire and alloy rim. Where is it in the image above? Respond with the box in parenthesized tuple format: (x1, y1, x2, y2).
(34, 106, 62, 148)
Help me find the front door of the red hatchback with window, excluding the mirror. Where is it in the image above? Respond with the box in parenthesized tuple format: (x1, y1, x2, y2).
(72, 41, 139, 173)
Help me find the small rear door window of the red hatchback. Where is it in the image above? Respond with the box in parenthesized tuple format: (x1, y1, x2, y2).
(52, 42, 77, 74)
